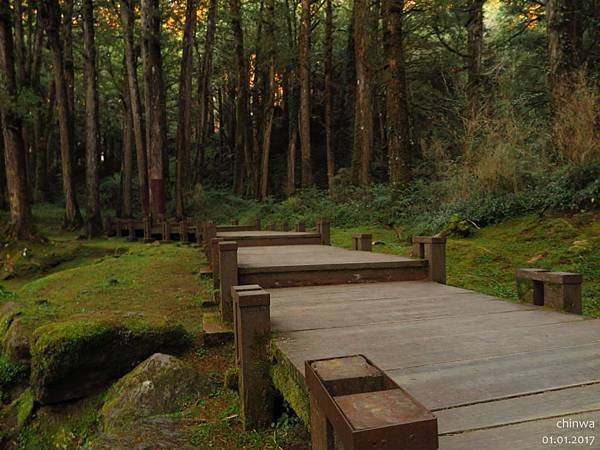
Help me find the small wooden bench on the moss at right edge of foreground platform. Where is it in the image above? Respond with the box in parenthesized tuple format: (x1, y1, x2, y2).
(516, 269, 583, 314)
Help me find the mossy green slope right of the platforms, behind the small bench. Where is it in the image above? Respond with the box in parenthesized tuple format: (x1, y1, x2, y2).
(332, 213, 600, 317)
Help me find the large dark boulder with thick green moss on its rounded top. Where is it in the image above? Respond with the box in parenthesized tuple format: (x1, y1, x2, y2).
(31, 312, 191, 404)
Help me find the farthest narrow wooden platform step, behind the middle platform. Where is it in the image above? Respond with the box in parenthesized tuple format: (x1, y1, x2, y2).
(217, 230, 321, 247)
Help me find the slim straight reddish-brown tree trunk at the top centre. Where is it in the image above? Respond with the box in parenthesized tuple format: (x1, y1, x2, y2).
(299, 0, 312, 188)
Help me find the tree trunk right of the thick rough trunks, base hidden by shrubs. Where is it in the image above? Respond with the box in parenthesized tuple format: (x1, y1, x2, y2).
(467, 0, 485, 120)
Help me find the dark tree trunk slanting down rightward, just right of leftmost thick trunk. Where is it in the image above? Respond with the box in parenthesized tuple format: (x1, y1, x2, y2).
(40, 0, 83, 229)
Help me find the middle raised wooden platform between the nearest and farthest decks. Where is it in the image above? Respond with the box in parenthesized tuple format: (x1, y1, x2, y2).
(237, 246, 428, 288)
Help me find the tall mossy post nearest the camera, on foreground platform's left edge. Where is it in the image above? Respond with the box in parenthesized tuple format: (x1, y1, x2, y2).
(237, 290, 273, 430)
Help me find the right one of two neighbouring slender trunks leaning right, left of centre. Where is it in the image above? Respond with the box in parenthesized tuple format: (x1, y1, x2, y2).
(195, 0, 222, 182)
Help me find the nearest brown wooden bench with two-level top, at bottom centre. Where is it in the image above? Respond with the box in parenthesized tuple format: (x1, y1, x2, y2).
(305, 355, 439, 450)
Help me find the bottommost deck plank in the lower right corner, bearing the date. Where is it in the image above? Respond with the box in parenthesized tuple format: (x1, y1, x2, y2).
(440, 411, 600, 450)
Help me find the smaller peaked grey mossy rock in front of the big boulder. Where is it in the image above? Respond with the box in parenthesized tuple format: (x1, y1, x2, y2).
(100, 353, 208, 431)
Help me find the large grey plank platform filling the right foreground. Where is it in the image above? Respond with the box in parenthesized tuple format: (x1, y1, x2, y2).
(272, 282, 600, 450)
